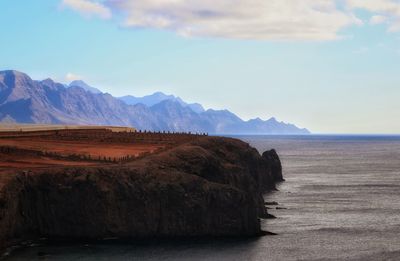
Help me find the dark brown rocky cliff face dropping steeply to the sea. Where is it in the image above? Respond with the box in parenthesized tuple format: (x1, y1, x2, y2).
(0, 137, 282, 248)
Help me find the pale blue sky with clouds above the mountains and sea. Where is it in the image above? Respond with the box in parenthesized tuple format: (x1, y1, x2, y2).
(0, 0, 400, 134)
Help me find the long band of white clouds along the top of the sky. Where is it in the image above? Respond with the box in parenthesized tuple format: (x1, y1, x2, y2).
(62, 0, 400, 41)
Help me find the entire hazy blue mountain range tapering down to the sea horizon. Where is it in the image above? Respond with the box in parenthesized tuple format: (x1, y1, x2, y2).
(0, 71, 309, 134)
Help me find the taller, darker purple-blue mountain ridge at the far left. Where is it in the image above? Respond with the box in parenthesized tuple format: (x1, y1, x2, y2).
(0, 71, 157, 128)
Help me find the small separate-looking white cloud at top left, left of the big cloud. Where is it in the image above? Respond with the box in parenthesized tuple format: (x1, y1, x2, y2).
(62, 0, 112, 19)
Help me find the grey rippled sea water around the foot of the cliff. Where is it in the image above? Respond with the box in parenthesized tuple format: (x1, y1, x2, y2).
(7, 136, 400, 261)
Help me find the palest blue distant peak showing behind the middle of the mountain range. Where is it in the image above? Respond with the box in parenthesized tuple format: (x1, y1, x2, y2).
(118, 92, 204, 113)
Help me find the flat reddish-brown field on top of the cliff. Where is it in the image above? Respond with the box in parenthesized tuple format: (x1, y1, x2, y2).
(0, 125, 203, 174)
